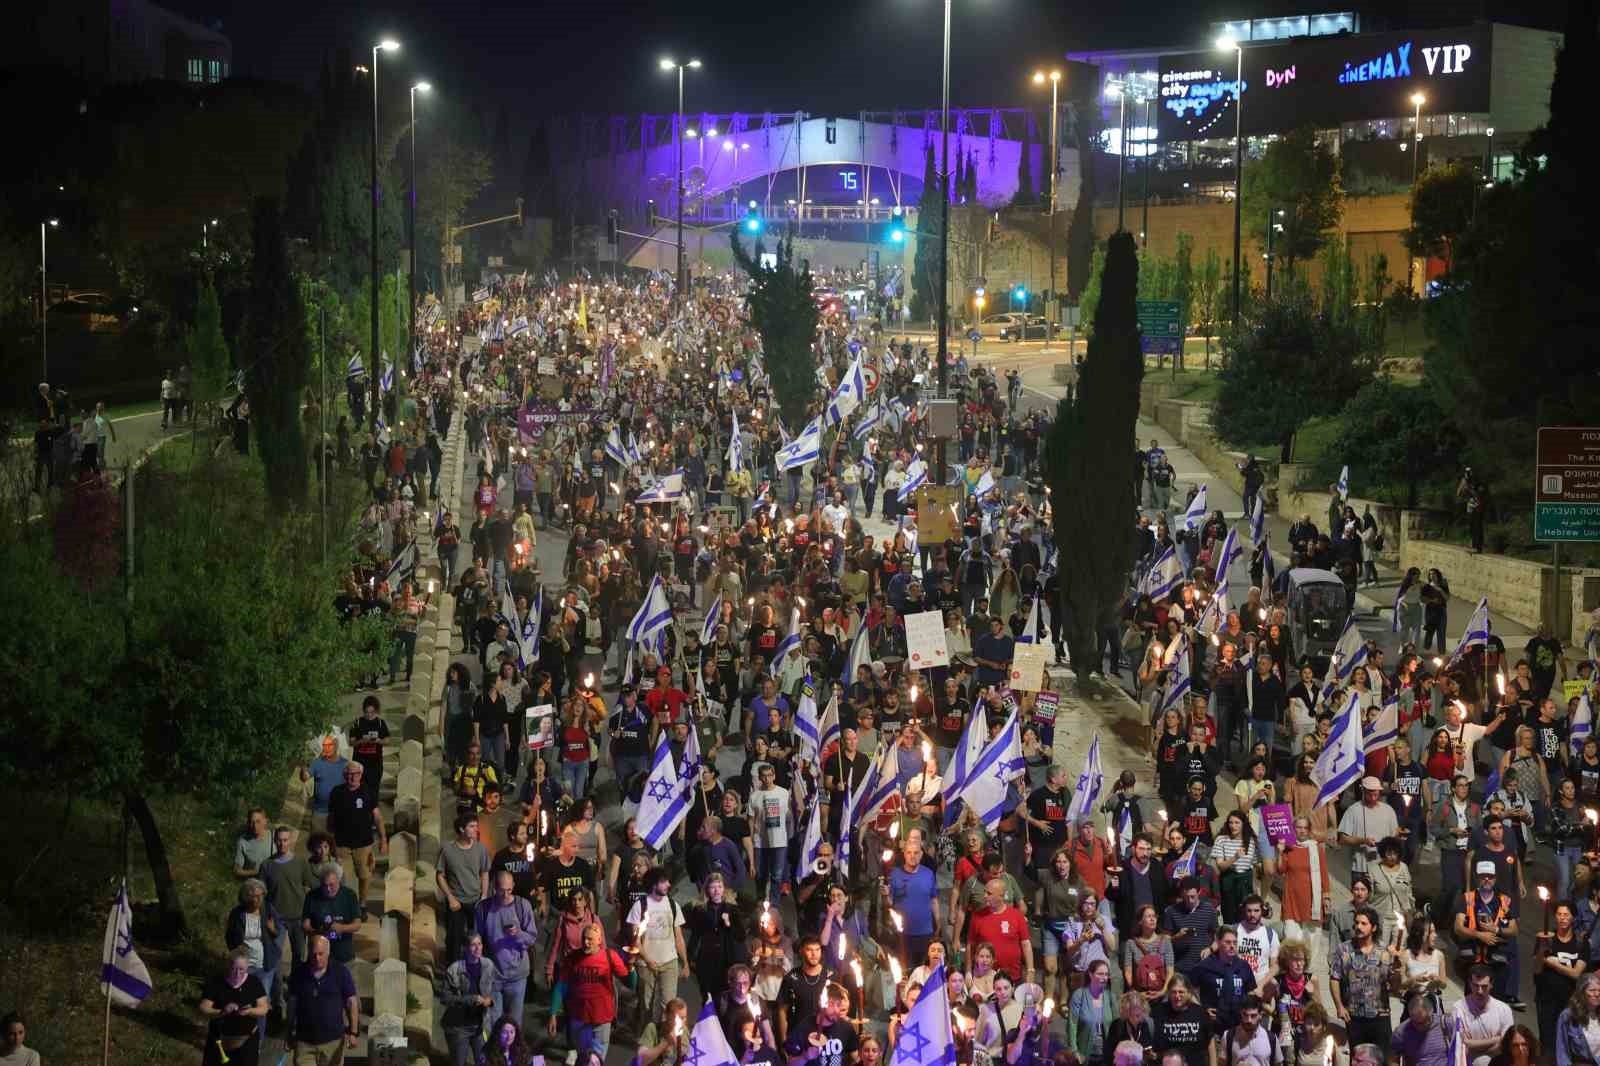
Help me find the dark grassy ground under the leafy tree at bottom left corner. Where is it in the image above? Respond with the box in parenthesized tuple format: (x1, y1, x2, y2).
(0, 789, 265, 1066)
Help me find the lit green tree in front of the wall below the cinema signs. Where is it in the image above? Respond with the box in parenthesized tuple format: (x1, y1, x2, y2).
(1242, 126, 1344, 275)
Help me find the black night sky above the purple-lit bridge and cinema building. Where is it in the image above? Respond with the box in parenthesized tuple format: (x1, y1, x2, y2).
(165, 0, 1563, 115)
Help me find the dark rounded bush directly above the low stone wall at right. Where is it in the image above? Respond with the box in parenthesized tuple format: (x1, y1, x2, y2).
(1315, 378, 1464, 507)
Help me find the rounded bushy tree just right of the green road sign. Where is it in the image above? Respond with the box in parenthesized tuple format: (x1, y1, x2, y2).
(1211, 291, 1378, 463)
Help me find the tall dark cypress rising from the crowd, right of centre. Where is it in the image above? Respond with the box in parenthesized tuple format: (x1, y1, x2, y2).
(1045, 234, 1144, 680)
